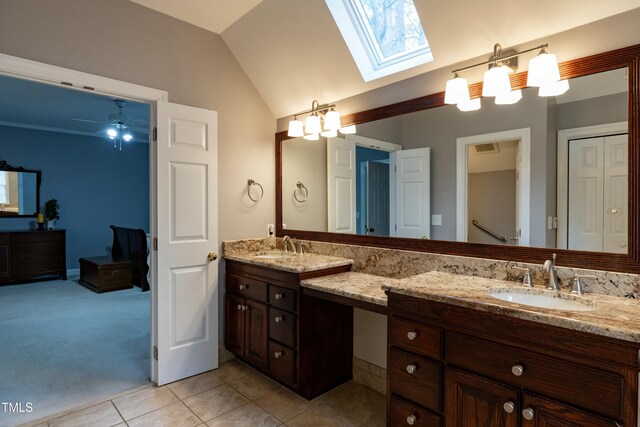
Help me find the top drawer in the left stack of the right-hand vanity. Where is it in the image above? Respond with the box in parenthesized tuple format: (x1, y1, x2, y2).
(389, 317, 442, 359)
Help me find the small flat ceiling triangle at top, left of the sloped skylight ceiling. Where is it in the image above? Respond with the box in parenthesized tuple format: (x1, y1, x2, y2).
(131, 0, 262, 34)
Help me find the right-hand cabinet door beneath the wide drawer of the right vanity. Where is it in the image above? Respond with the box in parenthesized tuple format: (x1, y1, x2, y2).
(522, 393, 620, 427)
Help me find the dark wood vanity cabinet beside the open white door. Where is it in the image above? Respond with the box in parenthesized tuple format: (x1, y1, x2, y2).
(225, 260, 353, 399)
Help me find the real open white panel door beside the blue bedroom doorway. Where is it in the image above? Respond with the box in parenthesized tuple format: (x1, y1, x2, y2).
(154, 102, 218, 385)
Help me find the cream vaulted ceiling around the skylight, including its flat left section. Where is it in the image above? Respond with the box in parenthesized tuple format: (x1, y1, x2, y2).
(132, 0, 640, 117)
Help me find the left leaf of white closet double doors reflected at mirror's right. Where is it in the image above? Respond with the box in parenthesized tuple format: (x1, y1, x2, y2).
(568, 138, 604, 252)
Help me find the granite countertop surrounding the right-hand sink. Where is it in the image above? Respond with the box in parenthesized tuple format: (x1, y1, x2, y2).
(384, 271, 640, 343)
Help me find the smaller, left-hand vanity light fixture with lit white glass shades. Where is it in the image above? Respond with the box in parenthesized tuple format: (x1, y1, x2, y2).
(287, 100, 356, 141)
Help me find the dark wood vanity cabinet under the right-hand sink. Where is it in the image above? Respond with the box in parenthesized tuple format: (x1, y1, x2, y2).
(388, 293, 640, 427)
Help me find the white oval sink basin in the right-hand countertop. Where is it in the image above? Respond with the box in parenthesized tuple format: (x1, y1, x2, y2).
(489, 289, 594, 311)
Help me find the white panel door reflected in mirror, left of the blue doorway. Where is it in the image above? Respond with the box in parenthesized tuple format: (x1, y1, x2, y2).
(327, 138, 356, 234)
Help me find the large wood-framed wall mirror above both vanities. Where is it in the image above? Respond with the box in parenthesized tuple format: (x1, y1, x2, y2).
(276, 46, 640, 272)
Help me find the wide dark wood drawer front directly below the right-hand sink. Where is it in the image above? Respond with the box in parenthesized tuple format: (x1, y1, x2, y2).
(445, 332, 624, 418)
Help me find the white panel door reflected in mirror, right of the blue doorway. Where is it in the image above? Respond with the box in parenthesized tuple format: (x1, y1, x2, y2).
(395, 148, 431, 239)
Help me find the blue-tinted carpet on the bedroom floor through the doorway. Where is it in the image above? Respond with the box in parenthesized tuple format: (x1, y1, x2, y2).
(0, 280, 151, 426)
